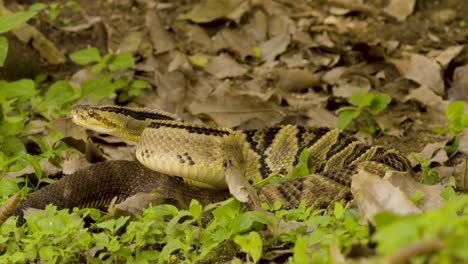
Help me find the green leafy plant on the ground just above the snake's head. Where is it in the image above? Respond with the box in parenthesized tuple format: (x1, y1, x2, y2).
(70, 48, 150, 102)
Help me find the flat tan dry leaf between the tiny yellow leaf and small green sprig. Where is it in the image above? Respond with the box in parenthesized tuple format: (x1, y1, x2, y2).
(204, 53, 248, 79)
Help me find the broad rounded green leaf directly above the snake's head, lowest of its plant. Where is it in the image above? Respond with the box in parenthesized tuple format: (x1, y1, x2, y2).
(81, 74, 115, 100)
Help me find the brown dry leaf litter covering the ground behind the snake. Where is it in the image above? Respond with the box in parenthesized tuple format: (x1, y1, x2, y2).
(2, 0, 468, 259)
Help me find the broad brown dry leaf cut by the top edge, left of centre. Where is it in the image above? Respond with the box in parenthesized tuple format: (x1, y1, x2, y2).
(179, 0, 249, 23)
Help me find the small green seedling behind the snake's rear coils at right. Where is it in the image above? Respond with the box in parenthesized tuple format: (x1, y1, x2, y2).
(337, 89, 392, 134)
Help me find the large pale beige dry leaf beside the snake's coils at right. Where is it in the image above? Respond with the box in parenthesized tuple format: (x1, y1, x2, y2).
(351, 170, 421, 222)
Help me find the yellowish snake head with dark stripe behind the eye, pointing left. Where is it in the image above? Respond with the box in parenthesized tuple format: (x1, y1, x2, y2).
(72, 105, 179, 141)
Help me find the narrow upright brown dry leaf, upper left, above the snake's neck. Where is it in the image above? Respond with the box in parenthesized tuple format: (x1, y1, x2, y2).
(146, 9, 175, 54)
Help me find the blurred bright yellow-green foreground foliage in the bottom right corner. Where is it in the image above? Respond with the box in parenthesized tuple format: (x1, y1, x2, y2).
(371, 195, 468, 263)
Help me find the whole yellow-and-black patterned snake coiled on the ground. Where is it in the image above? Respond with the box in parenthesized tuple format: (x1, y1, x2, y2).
(11, 105, 412, 224)
